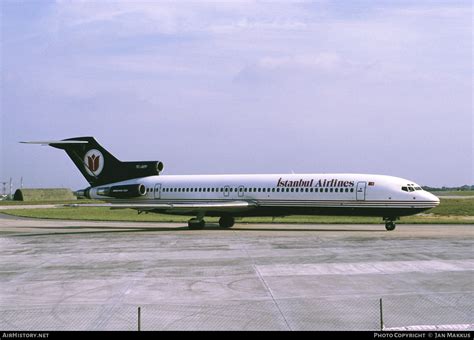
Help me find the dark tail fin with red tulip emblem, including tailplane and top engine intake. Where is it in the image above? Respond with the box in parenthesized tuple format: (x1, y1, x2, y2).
(21, 137, 163, 186)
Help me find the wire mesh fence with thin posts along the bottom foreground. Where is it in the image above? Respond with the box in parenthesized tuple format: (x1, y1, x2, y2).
(0, 294, 474, 331)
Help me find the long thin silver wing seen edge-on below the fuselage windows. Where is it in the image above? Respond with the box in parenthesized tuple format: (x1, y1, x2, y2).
(64, 201, 257, 213)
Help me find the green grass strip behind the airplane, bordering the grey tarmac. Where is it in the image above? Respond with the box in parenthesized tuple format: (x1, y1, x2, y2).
(2, 198, 474, 224)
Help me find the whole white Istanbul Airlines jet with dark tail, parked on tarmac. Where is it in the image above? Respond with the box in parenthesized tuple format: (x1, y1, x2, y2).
(21, 137, 440, 230)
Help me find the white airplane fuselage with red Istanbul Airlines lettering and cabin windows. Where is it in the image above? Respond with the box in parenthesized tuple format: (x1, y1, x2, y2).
(89, 174, 439, 216)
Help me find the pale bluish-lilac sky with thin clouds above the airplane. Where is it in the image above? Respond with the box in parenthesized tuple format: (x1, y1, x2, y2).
(0, 0, 474, 189)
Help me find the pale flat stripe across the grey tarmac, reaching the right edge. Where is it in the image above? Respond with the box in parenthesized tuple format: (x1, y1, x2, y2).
(257, 260, 474, 276)
